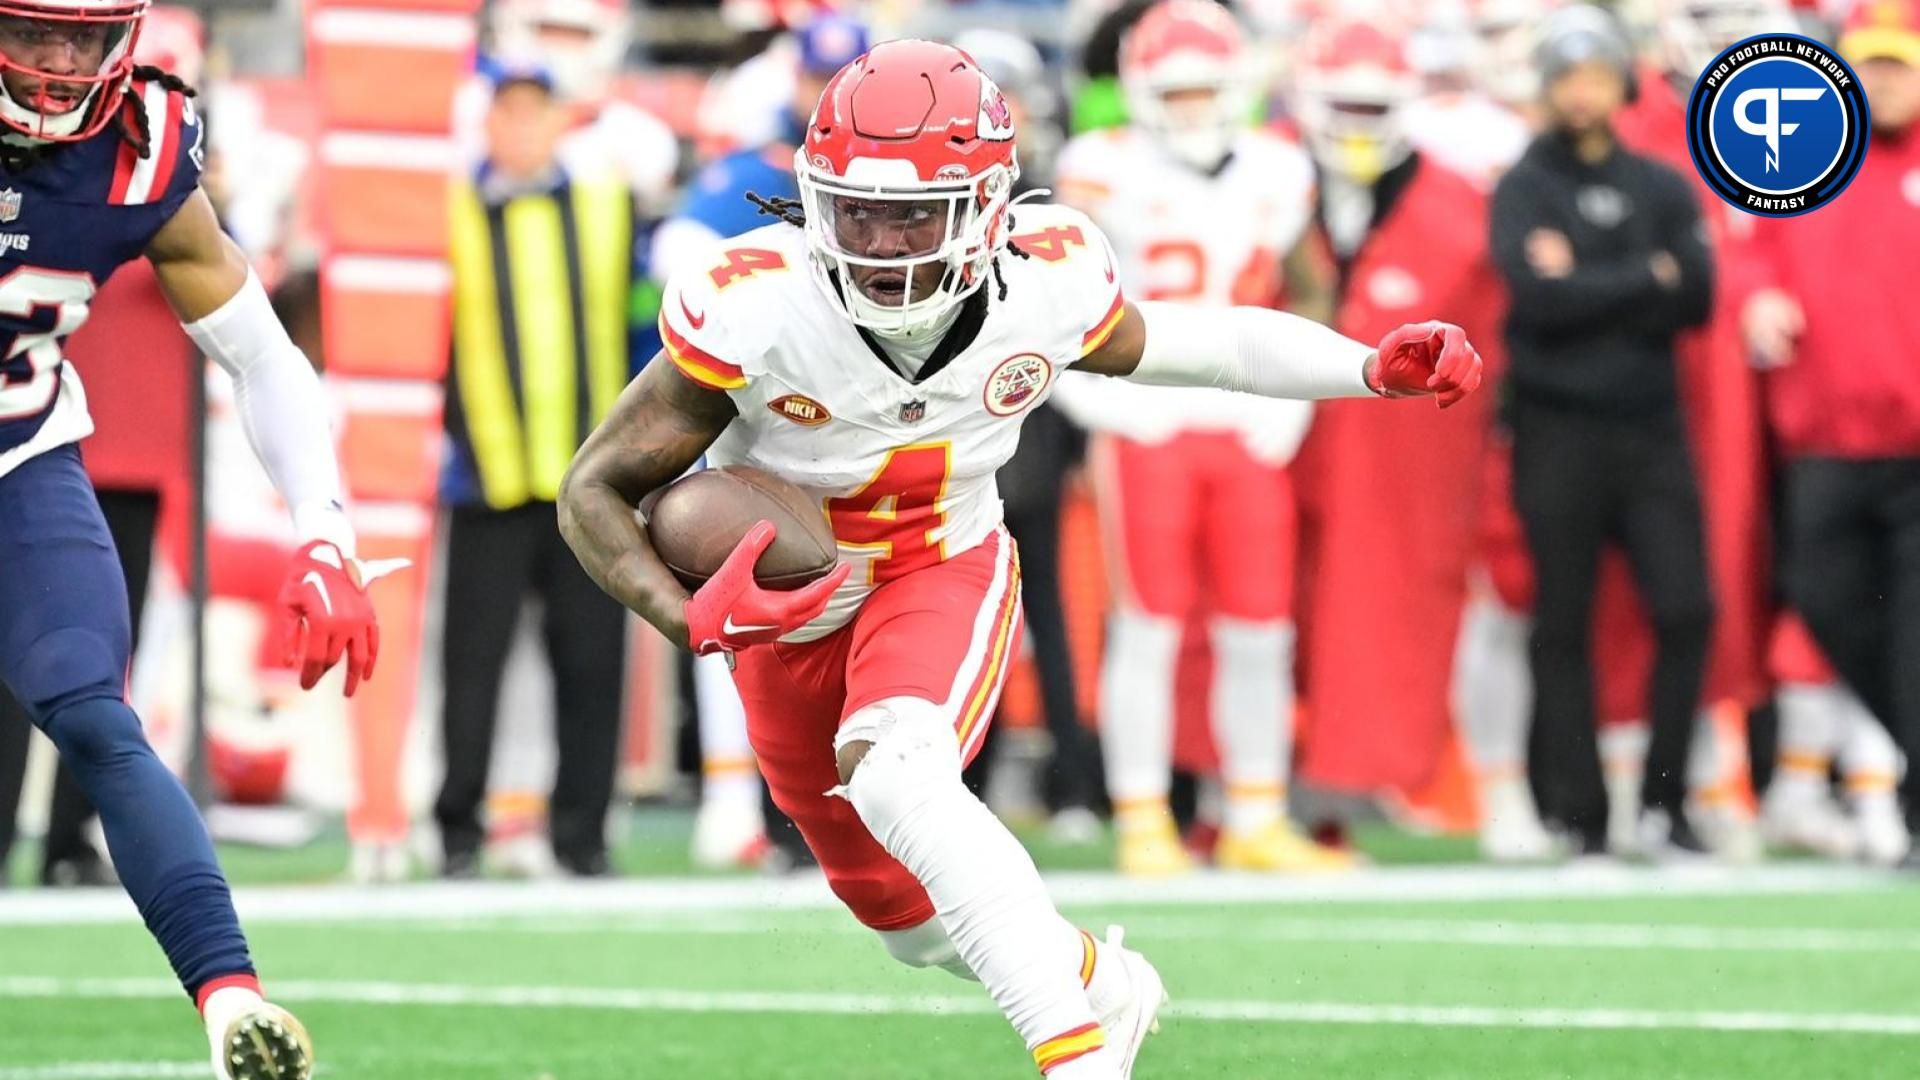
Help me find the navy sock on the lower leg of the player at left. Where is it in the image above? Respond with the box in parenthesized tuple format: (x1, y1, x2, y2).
(44, 698, 253, 997)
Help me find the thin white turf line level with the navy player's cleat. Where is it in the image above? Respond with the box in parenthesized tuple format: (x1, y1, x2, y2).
(0, 976, 1920, 1037)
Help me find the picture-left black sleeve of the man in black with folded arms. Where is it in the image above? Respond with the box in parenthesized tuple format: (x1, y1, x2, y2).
(1492, 169, 1661, 332)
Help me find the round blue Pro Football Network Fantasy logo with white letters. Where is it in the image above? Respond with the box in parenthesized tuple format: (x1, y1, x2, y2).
(1686, 33, 1868, 217)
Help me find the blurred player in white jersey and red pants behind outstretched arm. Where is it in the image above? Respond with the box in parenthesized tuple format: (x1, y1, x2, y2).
(1060, 0, 1350, 874)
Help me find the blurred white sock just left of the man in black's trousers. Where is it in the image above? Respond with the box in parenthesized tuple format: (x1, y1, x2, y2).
(1453, 598, 1534, 787)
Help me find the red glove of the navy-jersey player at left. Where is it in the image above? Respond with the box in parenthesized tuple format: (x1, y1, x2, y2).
(280, 540, 380, 698)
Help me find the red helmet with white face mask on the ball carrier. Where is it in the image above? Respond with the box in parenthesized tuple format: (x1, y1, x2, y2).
(793, 40, 1020, 332)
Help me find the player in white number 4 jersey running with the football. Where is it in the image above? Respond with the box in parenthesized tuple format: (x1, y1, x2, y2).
(561, 40, 1480, 1080)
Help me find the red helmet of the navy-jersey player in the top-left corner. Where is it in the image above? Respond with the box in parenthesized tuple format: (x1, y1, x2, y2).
(0, 0, 148, 142)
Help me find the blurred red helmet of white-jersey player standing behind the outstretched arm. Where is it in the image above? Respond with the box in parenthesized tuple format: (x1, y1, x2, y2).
(1119, 0, 1254, 169)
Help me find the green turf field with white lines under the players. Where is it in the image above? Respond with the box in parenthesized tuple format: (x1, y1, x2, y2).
(0, 810, 1920, 1080)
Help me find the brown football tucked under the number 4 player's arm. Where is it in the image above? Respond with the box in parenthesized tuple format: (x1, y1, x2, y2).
(639, 465, 839, 592)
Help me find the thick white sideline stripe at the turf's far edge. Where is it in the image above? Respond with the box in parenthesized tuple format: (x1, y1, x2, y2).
(0, 863, 1910, 926)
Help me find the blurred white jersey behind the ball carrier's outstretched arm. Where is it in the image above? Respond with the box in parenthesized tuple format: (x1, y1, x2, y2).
(1058, 129, 1313, 463)
